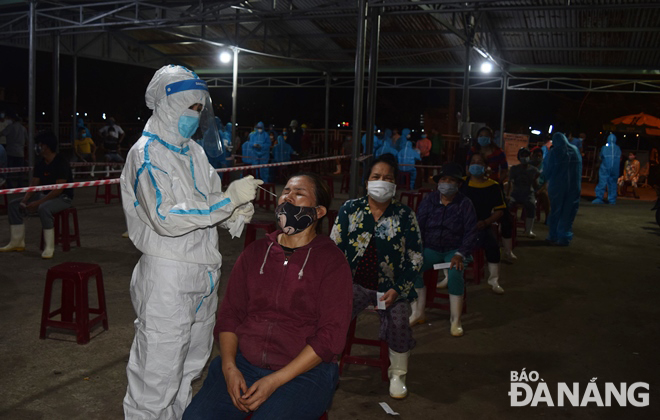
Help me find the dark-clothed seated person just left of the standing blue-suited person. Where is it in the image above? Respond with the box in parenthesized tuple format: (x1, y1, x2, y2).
(506, 147, 541, 239)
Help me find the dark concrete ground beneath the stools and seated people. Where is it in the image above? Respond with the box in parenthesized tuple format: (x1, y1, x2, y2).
(0, 179, 660, 420)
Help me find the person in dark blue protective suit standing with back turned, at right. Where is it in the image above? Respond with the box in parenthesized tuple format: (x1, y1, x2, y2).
(543, 133, 584, 246)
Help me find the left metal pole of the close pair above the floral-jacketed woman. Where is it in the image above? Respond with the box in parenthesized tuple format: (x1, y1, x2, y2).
(348, 0, 367, 198)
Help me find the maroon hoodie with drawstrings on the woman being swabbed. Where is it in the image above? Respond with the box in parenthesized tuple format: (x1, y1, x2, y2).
(215, 231, 353, 370)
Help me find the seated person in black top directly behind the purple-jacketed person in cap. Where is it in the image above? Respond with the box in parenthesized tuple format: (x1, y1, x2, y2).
(461, 153, 508, 295)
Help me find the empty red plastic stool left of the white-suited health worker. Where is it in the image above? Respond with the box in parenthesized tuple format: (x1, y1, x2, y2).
(39, 262, 108, 344)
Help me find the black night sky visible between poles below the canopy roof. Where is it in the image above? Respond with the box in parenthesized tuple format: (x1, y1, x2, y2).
(0, 47, 660, 150)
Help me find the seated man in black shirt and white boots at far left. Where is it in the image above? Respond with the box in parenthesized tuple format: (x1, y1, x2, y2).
(0, 131, 73, 258)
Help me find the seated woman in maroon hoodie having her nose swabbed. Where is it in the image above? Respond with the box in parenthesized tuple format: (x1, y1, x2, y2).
(183, 174, 353, 420)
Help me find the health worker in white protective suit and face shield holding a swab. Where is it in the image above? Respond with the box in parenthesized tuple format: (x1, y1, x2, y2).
(121, 65, 262, 419)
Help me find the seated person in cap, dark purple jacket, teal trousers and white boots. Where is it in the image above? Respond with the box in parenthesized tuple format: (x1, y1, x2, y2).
(409, 162, 477, 337)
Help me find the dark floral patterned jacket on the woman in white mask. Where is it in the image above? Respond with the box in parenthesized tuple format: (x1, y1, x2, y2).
(330, 196, 423, 300)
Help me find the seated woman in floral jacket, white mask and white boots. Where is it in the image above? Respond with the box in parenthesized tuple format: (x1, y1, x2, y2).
(330, 154, 423, 398)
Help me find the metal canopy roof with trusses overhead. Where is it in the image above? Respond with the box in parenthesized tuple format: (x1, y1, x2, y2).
(0, 0, 660, 77)
